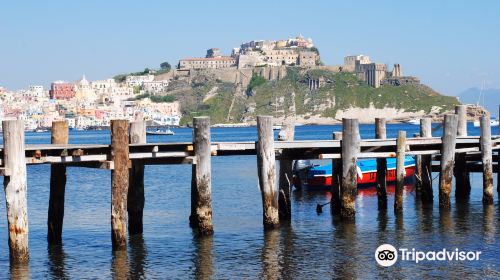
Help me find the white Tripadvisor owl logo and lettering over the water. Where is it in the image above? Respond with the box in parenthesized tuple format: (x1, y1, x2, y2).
(375, 244, 481, 267)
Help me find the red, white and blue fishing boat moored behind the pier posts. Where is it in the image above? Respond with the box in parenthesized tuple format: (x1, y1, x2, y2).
(293, 156, 415, 189)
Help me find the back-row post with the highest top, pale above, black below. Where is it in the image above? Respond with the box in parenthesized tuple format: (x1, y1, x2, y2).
(454, 105, 471, 198)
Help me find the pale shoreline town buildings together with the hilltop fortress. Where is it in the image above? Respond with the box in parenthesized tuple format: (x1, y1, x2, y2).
(0, 36, 420, 131)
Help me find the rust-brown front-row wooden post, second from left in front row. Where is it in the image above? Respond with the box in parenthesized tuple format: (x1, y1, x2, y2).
(111, 120, 129, 250)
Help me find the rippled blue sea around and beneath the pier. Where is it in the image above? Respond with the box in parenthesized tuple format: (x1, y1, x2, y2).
(0, 125, 500, 279)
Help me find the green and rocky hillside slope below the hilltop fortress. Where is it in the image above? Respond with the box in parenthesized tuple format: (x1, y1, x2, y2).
(160, 67, 458, 124)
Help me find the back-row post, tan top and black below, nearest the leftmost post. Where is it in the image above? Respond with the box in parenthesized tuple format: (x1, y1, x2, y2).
(47, 121, 69, 245)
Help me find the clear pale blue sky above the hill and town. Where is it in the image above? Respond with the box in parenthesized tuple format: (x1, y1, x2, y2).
(0, 0, 500, 95)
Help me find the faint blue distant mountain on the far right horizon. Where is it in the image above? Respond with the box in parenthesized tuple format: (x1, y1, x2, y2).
(457, 87, 500, 116)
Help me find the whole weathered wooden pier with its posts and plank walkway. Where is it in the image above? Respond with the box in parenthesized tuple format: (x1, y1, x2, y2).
(0, 106, 500, 263)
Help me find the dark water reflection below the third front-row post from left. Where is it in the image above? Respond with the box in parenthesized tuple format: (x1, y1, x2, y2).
(193, 232, 214, 279)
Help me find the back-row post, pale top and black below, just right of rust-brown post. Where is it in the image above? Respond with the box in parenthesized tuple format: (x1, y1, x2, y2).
(127, 120, 146, 234)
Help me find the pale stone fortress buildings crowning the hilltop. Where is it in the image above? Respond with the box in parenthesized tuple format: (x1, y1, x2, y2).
(169, 35, 420, 89)
